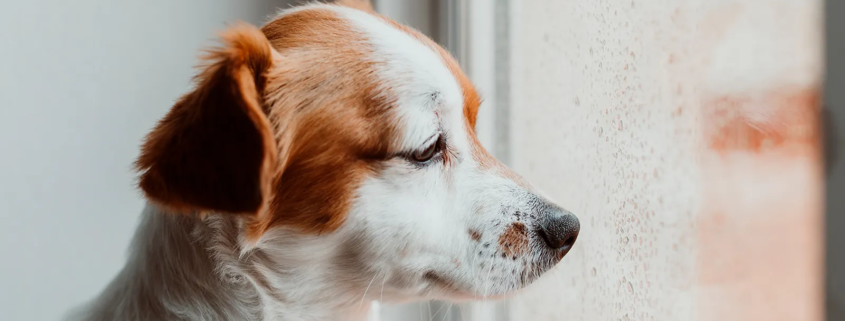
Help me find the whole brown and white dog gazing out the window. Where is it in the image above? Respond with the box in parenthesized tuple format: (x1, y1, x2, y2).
(72, 4, 579, 321)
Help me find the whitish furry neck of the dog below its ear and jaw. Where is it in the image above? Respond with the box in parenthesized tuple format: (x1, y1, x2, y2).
(75, 205, 370, 321)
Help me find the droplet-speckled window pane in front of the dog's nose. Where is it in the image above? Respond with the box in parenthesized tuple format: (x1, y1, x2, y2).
(510, 0, 823, 321)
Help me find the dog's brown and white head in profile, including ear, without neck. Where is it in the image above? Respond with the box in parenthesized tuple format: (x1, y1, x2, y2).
(138, 5, 579, 299)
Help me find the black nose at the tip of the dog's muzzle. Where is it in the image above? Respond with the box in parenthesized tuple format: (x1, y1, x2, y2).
(537, 208, 581, 252)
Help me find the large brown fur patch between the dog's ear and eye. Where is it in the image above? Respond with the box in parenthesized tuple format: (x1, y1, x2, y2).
(254, 9, 395, 234)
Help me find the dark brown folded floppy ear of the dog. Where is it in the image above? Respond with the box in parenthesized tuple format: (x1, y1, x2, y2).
(136, 24, 276, 213)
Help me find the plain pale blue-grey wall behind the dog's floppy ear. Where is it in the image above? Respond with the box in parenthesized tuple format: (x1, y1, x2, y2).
(0, 0, 284, 320)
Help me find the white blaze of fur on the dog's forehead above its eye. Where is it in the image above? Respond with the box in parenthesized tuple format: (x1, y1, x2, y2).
(338, 8, 464, 148)
